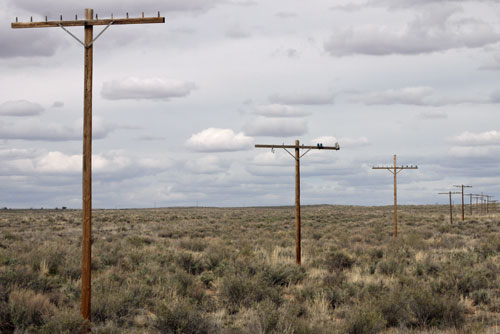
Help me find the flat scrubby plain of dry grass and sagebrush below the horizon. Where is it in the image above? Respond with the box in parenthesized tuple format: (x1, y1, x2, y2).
(0, 205, 500, 334)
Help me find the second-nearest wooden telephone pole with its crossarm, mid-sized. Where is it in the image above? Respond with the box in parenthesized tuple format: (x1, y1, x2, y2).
(255, 140, 340, 265)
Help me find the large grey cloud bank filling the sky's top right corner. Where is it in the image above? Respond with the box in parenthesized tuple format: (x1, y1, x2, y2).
(324, 3, 500, 56)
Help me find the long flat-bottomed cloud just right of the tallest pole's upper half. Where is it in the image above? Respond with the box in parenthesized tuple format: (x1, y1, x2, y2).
(101, 77, 196, 100)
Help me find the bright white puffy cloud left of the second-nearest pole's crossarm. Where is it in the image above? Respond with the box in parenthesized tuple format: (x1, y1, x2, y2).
(186, 128, 253, 152)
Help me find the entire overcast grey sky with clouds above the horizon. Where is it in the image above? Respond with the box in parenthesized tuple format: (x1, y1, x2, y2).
(0, 0, 500, 208)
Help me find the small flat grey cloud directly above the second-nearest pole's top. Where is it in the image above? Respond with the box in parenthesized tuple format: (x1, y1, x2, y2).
(244, 117, 307, 137)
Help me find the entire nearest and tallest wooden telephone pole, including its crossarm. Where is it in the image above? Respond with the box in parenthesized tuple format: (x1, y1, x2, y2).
(11, 8, 165, 324)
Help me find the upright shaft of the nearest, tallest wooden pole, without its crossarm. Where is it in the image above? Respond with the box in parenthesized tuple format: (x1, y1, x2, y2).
(82, 9, 94, 320)
